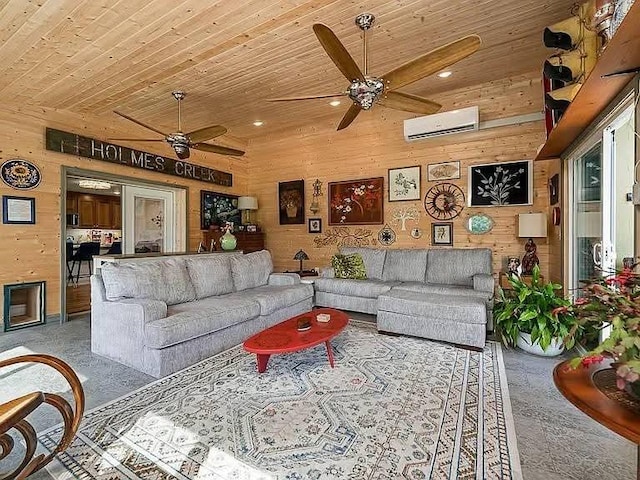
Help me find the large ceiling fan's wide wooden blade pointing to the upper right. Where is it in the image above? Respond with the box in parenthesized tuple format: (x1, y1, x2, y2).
(382, 35, 481, 90)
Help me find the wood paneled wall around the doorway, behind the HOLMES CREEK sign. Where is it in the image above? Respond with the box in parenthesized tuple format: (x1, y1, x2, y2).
(0, 105, 248, 315)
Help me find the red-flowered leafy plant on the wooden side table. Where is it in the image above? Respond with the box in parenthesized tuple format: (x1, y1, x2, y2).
(562, 268, 640, 397)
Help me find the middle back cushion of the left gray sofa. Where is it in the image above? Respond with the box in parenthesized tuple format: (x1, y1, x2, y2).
(186, 253, 233, 299)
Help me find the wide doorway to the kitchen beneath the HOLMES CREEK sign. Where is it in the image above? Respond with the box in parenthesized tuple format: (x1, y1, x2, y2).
(60, 168, 187, 322)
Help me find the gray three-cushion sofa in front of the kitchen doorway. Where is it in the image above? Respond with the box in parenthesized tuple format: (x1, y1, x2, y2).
(91, 250, 313, 378)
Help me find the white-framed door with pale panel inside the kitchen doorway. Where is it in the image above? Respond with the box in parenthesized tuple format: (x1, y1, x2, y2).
(122, 185, 180, 254)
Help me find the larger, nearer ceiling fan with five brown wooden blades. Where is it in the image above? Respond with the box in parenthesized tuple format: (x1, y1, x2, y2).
(269, 13, 481, 130)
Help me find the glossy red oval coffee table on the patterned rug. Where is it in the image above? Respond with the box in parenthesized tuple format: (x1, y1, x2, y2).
(243, 308, 349, 373)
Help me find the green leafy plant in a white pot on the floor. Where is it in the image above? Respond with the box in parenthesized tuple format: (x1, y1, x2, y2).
(493, 265, 578, 356)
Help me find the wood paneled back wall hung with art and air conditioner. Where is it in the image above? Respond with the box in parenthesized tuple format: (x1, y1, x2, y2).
(249, 72, 555, 282)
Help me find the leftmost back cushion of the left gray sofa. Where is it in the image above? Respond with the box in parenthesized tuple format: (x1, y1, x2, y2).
(101, 258, 196, 305)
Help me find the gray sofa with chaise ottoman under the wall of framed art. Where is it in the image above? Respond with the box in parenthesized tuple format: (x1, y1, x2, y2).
(315, 247, 494, 348)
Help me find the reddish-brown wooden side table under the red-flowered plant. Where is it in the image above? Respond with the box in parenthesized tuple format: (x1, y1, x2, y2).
(553, 360, 640, 480)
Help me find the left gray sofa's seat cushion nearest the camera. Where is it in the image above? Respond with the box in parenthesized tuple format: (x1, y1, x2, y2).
(144, 293, 260, 349)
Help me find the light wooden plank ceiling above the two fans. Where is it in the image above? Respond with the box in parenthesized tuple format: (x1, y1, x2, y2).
(0, 0, 574, 139)
